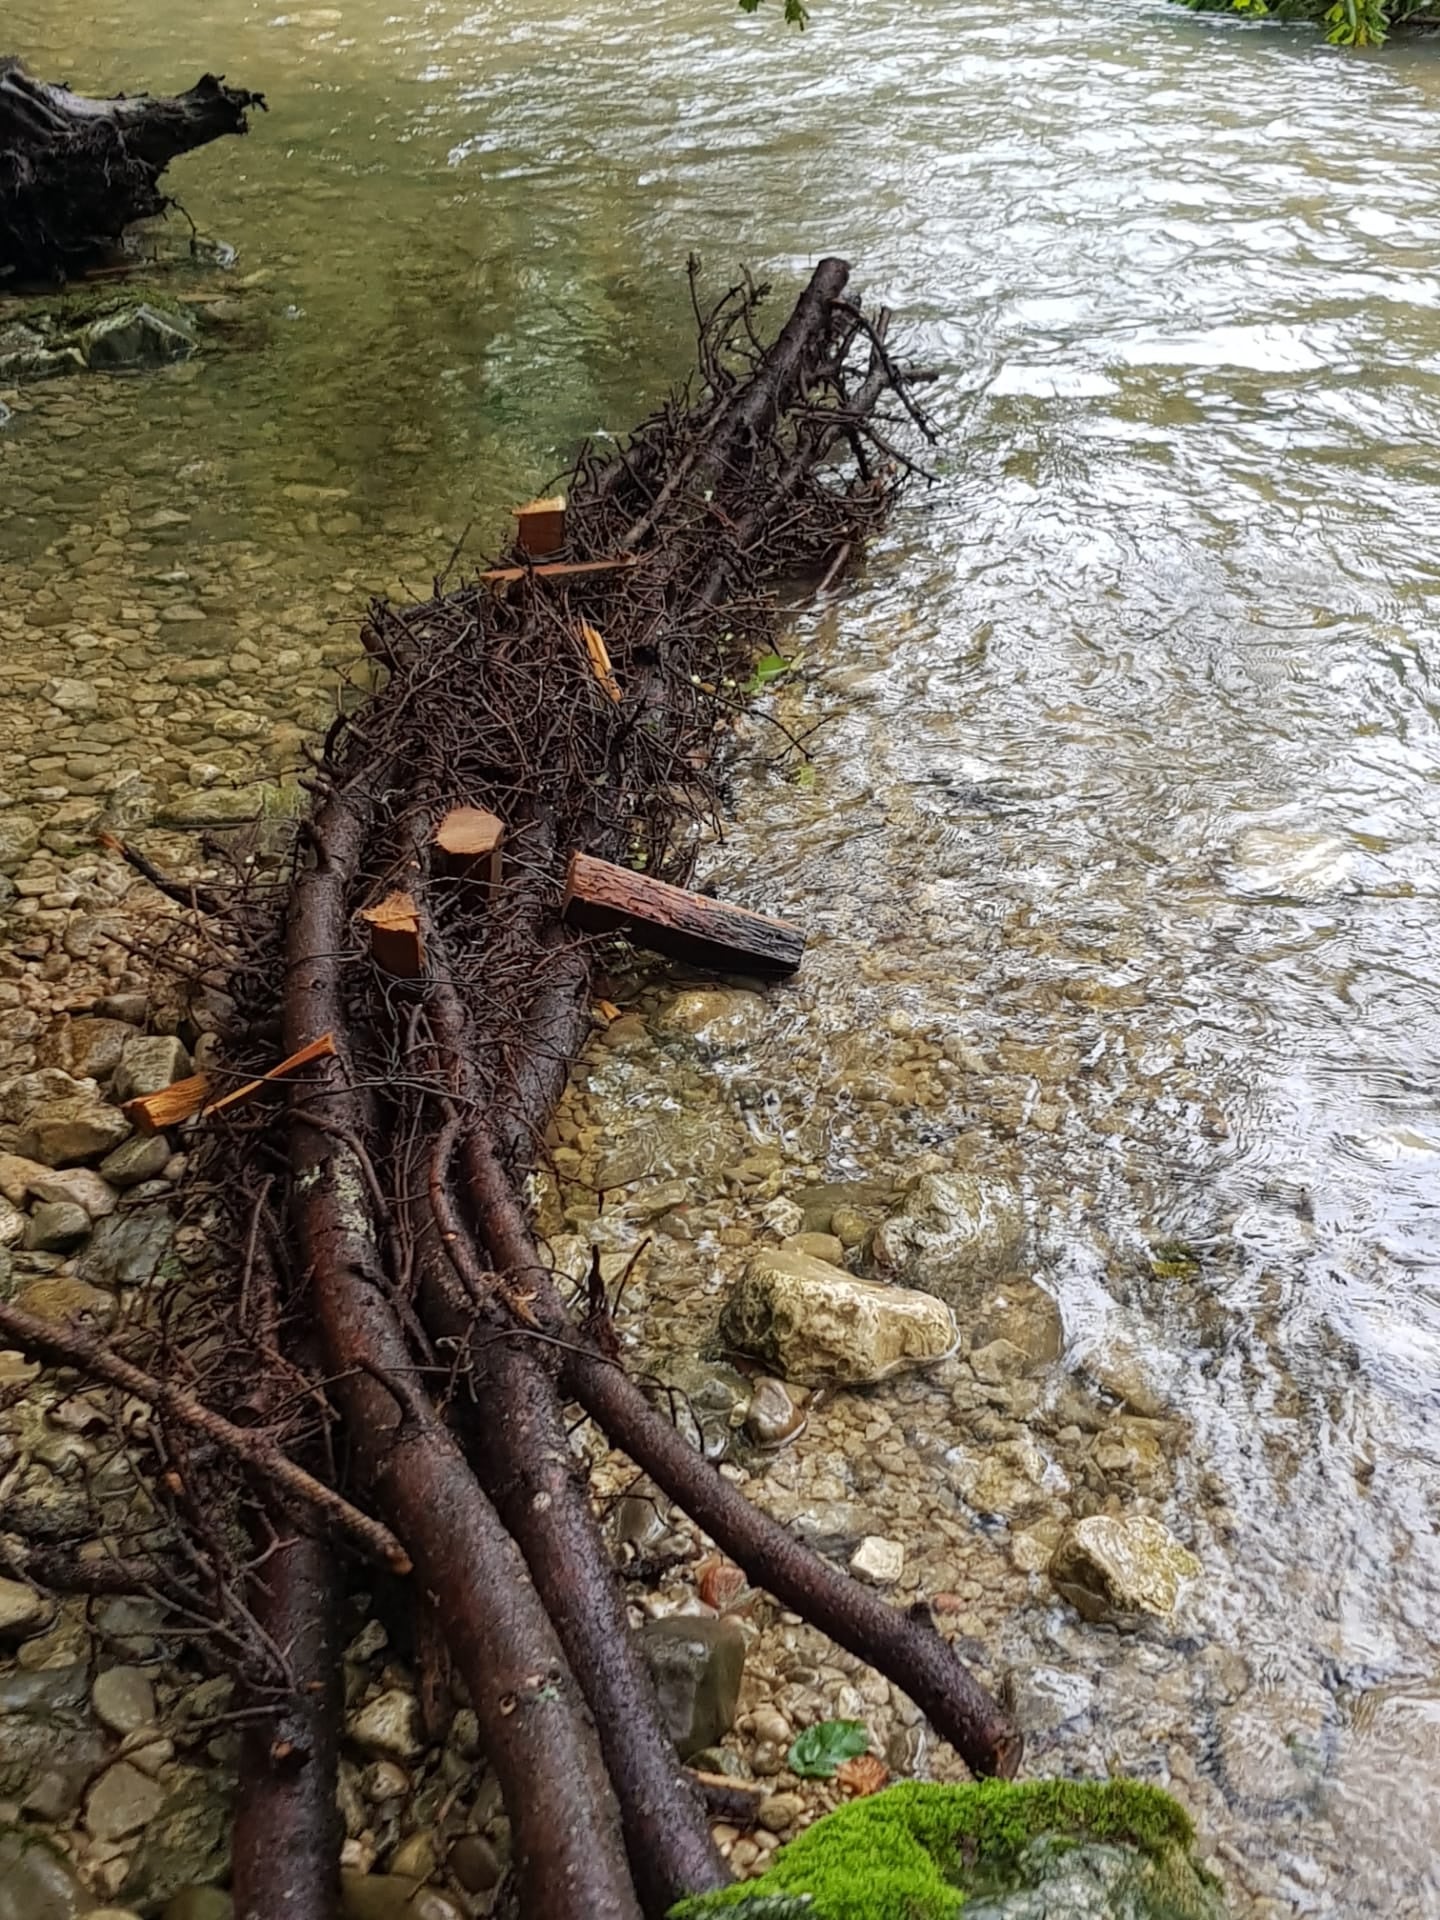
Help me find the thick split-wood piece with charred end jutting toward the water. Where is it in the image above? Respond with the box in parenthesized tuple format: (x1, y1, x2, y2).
(564, 852, 804, 975)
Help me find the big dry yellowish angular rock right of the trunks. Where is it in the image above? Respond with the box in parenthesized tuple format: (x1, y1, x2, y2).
(720, 1248, 956, 1386)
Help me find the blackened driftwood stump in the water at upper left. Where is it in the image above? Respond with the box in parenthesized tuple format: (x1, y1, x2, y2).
(0, 58, 265, 282)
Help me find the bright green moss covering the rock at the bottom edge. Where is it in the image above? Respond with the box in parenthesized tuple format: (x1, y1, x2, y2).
(672, 1780, 1194, 1920)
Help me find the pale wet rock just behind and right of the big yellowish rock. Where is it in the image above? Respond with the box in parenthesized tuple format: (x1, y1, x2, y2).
(870, 1173, 1025, 1308)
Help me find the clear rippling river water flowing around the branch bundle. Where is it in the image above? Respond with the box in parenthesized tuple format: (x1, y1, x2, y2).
(0, 0, 1440, 1916)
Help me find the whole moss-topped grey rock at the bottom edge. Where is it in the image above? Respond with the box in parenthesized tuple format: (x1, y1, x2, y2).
(670, 1780, 1223, 1920)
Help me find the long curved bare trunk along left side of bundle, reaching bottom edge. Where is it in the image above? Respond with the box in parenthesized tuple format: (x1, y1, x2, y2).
(284, 797, 639, 1920)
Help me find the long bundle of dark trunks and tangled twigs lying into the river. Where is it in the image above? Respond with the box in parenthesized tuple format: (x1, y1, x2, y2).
(0, 259, 1020, 1920)
